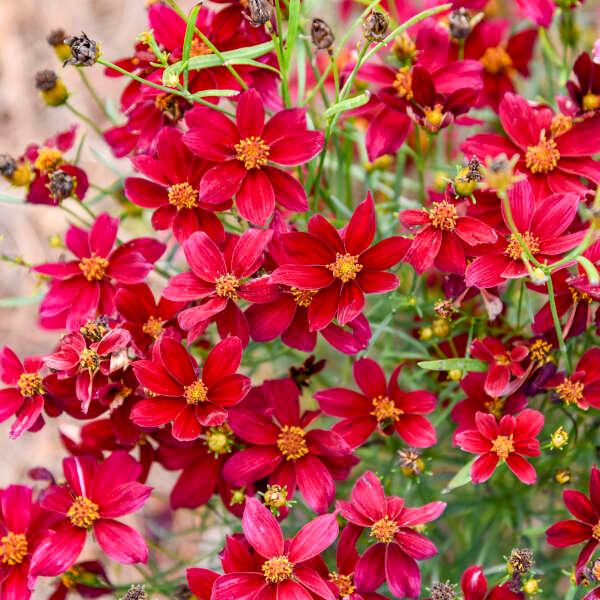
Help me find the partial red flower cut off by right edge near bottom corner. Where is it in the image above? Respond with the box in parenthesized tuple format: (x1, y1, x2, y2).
(546, 465, 600, 581)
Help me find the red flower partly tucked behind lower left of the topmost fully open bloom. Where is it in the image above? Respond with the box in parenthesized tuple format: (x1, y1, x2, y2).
(125, 127, 226, 242)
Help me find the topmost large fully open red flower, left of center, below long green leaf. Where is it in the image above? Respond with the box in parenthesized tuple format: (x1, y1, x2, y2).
(183, 89, 324, 225)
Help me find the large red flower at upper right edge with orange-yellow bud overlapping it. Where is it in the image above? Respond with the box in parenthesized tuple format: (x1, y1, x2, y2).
(462, 93, 600, 202)
